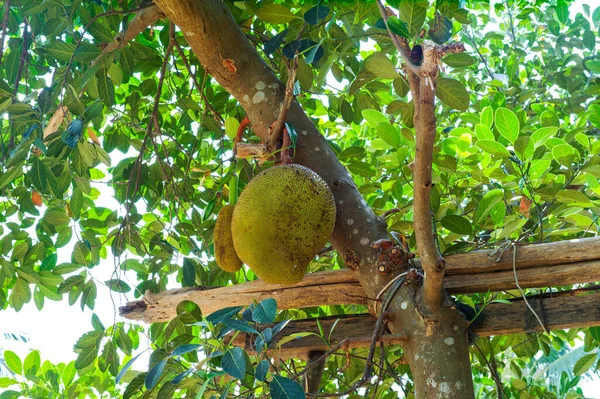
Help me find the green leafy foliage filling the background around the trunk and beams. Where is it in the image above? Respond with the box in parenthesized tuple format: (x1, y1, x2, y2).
(0, 0, 600, 399)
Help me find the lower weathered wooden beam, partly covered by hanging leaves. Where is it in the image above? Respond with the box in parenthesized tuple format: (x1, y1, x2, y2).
(233, 293, 600, 360)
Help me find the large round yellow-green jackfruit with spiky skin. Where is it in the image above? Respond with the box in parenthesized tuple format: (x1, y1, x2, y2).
(231, 164, 335, 284)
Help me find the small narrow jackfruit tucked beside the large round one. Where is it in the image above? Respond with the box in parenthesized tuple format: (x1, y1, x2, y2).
(213, 205, 243, 273)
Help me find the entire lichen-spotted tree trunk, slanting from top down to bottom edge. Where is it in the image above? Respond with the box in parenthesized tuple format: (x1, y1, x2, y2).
(155, 0, 474, 399)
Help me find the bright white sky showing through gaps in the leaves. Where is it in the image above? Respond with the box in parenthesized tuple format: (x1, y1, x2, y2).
(0, 0, 600, 398)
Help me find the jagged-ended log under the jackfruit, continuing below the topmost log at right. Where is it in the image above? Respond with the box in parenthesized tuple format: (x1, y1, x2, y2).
(119, 261, 600, 323)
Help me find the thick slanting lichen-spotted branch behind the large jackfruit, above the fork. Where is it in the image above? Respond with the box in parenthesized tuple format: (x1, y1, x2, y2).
(156, 0, 390, 297)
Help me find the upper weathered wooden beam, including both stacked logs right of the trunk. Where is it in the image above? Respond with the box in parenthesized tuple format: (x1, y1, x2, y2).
(120, 237, 600, 323)
